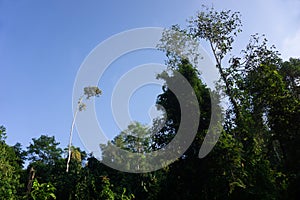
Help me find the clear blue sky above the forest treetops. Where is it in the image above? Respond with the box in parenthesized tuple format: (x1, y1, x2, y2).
(0, 0, 300, 155)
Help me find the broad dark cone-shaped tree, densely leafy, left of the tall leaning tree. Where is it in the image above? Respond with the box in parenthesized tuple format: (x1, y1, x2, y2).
(153, 58, 232, 199)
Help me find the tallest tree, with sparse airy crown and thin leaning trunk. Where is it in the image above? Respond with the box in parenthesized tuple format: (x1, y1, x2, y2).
(188, 6, 242, 121)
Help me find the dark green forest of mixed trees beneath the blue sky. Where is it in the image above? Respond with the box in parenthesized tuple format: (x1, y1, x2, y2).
(0, 8, 300, 200)
